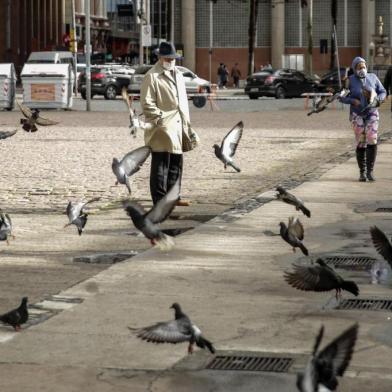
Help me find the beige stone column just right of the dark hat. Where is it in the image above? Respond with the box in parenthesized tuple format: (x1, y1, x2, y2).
(181, 0, 196, 71)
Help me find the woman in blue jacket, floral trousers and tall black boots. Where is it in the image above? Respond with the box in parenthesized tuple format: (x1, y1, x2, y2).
(340, 57, 386, 182)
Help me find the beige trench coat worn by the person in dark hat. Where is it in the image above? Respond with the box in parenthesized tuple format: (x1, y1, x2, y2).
(140, 61, 189, 154)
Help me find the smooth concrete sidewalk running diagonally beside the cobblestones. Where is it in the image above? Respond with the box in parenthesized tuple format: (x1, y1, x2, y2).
(0, 142, 392, 392)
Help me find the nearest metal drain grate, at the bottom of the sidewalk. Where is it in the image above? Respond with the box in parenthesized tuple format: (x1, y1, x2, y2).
(207, 355, 294, 373)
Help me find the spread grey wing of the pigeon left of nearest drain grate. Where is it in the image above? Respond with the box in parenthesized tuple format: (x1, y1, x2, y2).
(132, 320, 191, 344)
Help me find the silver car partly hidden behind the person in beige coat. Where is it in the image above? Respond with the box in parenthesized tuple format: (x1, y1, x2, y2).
(128, 65, 211, 94)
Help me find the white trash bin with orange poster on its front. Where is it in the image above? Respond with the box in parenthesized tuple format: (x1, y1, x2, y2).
(20, 64, 73, 109)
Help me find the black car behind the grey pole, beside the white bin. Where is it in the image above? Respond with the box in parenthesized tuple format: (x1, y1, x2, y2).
(78, 67, 130, 99)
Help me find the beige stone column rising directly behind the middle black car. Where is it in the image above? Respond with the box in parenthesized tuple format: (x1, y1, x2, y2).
(271, 0, 285, 68)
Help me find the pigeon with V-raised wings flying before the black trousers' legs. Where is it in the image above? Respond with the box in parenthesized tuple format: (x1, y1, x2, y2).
(124, 180, 180, 250)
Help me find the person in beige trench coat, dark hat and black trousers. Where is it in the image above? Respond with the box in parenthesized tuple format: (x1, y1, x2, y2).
(140, 42, 189, 205)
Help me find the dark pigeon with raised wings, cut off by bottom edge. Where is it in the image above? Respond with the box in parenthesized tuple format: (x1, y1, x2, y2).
(297, 324, 358, 392)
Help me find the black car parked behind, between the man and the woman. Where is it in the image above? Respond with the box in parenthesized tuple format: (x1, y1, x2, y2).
(245, 68, 318, 99)
